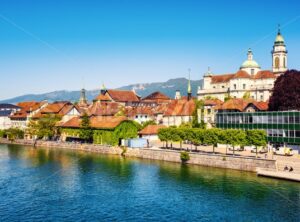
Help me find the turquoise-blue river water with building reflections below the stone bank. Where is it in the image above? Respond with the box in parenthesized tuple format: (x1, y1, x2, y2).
(0, 145, 300, 222)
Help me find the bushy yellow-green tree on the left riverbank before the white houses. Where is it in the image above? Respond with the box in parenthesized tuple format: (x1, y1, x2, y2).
(26, 115, 61, 139)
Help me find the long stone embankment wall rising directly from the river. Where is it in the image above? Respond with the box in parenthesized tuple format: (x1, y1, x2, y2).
(0, 140, 276, 172)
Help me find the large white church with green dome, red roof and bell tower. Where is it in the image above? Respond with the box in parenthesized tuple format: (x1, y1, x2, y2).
(198, 29, 287, 101)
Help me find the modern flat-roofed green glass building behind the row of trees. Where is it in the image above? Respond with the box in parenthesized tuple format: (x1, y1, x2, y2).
(216, 111, 300, 147)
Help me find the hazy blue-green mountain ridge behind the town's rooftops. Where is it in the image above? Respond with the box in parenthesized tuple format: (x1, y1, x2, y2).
(0, 78, 203, 103)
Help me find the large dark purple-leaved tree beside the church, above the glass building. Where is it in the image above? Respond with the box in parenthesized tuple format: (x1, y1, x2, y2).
(269, 70, 300, 111)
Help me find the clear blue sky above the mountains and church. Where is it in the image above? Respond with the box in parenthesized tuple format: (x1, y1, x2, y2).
(0, 0, 300, 99)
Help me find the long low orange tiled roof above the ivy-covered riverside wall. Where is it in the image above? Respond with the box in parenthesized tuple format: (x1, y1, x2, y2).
(60, 116, 127, 129)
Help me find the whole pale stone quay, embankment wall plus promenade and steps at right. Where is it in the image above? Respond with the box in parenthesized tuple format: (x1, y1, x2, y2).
(0, 139, 300, 182)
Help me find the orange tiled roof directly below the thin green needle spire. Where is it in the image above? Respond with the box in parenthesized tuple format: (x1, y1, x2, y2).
(164, 99, 196, 116)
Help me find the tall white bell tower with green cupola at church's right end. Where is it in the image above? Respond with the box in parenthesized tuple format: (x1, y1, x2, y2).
(272, 26, 288, 76)
